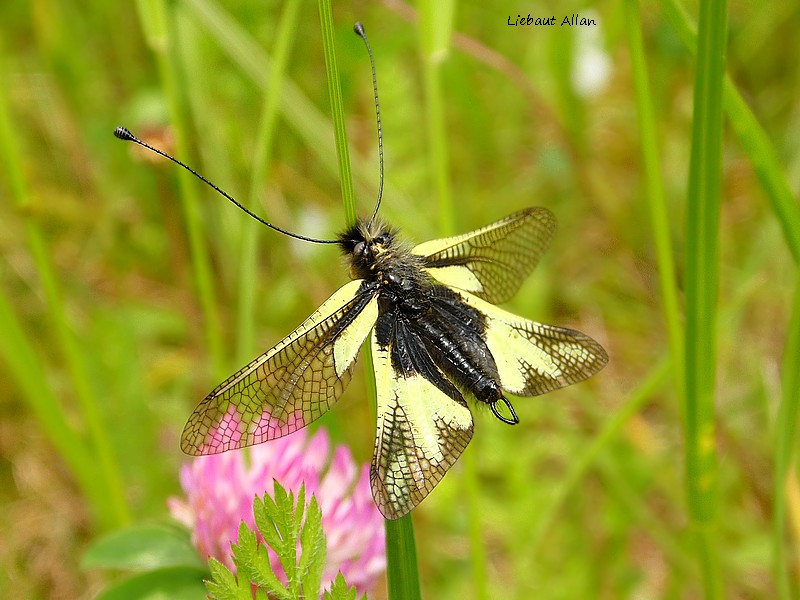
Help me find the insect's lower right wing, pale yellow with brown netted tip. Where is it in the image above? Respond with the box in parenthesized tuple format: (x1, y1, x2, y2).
(459, 292, 608, 396)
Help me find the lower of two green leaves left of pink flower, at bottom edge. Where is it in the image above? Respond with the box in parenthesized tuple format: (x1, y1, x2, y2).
(96, 567, 208, 600)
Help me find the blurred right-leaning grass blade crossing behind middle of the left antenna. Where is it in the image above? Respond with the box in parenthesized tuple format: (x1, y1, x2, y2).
(236, 0, 300, 362)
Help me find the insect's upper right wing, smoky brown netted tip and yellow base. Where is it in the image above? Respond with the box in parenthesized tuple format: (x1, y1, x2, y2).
(412, 208, 556, 304)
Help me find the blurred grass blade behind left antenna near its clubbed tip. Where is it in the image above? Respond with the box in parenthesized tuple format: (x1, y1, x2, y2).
(137, 0, 227, 377)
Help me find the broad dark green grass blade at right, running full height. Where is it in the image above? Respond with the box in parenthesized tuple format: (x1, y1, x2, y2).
(685, 0, 727, 598)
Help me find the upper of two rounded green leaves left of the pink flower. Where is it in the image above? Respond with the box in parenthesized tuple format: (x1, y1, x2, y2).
(81, 525, 205, 570)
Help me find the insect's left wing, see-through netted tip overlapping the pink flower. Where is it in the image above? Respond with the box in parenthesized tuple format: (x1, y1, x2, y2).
(181, 280, 378, 455)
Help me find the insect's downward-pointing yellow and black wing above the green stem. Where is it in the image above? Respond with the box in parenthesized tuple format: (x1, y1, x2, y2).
(370, 326, 472, 519)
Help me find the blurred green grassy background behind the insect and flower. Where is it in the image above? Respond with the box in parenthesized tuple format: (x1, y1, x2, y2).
(0, 0, 800, 599)
